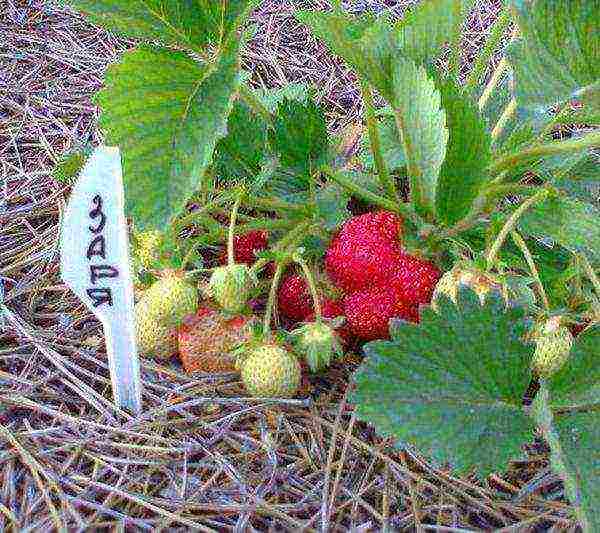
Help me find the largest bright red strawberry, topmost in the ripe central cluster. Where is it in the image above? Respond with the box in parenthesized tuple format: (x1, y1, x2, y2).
(325, 211, 402, 293)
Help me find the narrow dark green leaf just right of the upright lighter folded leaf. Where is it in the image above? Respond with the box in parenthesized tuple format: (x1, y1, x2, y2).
(436, 80, 492, 226)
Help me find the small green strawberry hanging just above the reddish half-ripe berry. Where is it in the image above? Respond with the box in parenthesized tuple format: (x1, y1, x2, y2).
(208, 264, 254, 314)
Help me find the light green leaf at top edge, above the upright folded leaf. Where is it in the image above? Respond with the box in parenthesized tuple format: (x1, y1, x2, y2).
(394, 0, 473, 63)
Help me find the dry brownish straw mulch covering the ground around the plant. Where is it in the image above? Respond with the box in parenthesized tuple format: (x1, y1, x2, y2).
(0, 0, 576, 531)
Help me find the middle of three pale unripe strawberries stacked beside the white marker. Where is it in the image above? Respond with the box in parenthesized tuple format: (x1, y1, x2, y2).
(136, 271, 198, 327)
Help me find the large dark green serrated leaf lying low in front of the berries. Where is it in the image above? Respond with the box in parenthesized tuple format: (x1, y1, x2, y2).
(351, 289, 532, 474)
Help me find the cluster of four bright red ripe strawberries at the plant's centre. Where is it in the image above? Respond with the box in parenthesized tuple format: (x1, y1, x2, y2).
(278, 211, 441, 340)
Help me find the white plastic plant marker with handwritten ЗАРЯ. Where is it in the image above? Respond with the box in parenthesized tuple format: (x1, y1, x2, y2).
(60, 146, 141, 414)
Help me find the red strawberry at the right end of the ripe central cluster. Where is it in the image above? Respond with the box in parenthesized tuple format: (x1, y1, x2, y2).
(391, 255, 442, 306)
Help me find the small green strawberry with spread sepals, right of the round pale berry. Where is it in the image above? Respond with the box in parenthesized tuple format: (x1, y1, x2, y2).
(291, 322, 343, 372)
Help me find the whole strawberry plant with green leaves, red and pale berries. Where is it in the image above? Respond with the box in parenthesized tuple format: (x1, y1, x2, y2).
(61, 0, 600, 531)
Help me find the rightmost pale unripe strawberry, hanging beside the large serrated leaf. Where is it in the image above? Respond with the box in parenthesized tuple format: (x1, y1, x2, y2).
(531, 316, 573, 378)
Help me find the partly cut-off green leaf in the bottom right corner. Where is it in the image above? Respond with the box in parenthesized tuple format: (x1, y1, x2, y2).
(533, 386, 600, 533)
